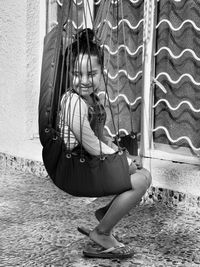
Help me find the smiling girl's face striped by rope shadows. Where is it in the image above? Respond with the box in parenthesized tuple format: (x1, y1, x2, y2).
(73, 54, 101, 99)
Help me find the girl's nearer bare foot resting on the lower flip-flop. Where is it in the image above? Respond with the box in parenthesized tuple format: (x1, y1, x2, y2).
(89, 228, 123, 249)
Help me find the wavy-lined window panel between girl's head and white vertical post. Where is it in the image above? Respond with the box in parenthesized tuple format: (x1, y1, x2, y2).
(95, 0, 143, 137)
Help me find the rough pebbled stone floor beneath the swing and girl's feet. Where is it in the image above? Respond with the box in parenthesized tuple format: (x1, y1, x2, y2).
(0, 164, 200, 267)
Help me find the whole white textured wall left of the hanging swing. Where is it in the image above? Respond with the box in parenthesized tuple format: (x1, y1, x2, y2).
(0, 0, 46, 158)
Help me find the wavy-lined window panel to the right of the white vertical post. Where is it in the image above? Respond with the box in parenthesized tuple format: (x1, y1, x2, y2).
(154, 0, 200, 151)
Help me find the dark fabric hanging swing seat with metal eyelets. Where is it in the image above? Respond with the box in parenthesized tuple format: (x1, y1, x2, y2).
(39, 28, 131, 197)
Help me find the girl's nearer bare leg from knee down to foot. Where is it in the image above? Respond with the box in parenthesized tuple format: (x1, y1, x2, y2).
(90, 169, 151, 248)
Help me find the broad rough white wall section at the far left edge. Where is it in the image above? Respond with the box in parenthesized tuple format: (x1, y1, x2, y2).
(0, 1, 26, 153)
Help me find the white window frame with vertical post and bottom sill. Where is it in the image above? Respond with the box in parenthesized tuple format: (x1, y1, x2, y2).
(140, 0, 200, 165)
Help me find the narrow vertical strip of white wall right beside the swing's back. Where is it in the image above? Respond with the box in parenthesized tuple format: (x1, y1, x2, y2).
(25, 0, 42, 140)
